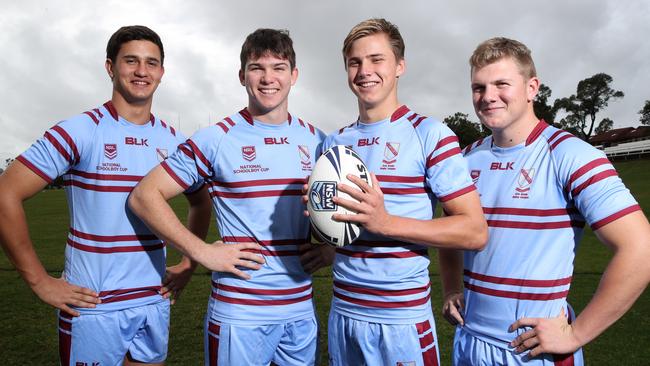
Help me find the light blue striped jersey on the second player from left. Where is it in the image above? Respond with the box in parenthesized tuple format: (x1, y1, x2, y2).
(163, 109, 324, 324)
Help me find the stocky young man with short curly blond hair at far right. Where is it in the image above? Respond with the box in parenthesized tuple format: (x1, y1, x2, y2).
(440, 38, 650, 365)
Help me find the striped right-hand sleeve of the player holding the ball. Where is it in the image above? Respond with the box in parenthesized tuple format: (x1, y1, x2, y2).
(421, 121, 476, 202)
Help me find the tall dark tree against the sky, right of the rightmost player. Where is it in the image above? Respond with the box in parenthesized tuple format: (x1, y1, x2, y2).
(554, 73, 625, 140)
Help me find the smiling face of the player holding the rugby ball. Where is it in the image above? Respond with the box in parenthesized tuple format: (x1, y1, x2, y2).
(345, 33, 405, 117)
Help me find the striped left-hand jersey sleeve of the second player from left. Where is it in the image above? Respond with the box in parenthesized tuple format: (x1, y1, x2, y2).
(160, 127, 222, 193)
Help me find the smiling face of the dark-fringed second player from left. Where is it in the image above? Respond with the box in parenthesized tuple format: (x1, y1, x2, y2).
(239, 53, 298, 122)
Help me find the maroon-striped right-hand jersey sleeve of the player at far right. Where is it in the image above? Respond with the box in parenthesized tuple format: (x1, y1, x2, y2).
(553, 133, 641, 230)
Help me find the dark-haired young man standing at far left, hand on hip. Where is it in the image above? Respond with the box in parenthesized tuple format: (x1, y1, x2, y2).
(0, 26, 247, 365)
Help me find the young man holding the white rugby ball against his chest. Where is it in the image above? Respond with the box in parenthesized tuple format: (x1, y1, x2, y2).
(323, 19, 487, 365)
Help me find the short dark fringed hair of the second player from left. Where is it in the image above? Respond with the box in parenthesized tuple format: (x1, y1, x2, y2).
(239, 28, 296, 70)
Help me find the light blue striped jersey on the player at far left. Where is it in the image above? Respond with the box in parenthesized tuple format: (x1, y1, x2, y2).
(17, 101, 194, 313)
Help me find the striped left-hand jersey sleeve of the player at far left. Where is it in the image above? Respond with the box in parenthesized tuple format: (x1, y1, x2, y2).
(16, 115, 97, 183)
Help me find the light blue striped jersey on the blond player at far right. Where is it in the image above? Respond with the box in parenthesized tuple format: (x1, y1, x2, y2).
(464, 121, 640, 348)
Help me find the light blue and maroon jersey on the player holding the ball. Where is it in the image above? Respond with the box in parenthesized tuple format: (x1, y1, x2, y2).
(323, 106, 475, 324)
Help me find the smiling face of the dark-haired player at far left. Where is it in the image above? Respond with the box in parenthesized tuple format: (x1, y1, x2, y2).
(106, 40, 165, 104)
